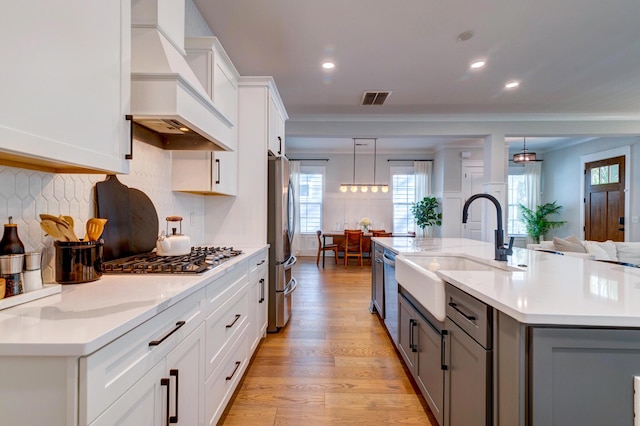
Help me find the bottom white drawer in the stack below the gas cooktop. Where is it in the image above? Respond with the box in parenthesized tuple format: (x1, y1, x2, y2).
(205, 325, 249, 425)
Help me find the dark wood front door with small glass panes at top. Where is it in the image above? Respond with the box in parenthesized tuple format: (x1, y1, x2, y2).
(584, 156, 625, 241)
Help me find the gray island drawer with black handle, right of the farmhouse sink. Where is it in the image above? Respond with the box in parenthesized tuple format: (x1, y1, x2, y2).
(446, 284, 493, 349)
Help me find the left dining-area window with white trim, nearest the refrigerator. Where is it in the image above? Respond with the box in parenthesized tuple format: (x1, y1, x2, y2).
(299, 166, 324, 234)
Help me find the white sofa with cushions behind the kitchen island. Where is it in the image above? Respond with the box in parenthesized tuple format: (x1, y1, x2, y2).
(527, 236, 640, 265)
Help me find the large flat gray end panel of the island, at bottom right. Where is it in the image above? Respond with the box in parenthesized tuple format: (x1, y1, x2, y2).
(529, 327, 640, 426)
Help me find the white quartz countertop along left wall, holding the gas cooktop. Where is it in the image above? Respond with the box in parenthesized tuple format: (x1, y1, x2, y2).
(0, 246, 266, 356)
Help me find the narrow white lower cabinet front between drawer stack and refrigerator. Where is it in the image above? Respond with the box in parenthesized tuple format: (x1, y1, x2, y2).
(249, 249, 269, 352)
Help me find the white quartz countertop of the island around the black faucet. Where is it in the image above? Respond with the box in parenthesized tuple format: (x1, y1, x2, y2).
(384, 238, 640, 327)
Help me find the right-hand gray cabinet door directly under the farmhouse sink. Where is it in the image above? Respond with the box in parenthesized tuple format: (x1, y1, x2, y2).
(414, 316, 444, 424)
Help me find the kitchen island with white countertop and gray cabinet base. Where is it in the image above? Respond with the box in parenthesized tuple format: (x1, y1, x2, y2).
(374, 238, 640, 425)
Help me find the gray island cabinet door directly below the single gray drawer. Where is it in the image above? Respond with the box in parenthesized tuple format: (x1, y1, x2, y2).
(444, 317, 491, 426)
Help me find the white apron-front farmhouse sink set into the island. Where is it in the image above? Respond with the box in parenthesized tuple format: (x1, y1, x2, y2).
(395, 255, 494, 321)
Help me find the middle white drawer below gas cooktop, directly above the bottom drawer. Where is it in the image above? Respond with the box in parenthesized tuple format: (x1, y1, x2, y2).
(205, 284, 249, 377)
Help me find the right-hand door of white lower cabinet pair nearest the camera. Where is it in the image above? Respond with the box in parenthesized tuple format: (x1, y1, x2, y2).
(165, 324, 205, 426)
